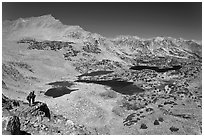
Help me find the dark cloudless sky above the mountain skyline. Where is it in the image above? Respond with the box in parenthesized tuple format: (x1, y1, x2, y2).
(2, 2, 202, 40)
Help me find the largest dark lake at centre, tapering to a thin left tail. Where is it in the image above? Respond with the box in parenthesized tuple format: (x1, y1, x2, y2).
(75, 80, 144, 95)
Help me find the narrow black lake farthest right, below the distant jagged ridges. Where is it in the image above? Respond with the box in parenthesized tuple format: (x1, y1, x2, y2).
(130, 65, 182, 73)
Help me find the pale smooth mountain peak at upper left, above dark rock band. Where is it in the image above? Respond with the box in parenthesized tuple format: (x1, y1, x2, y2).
(3, 14, 88, 40)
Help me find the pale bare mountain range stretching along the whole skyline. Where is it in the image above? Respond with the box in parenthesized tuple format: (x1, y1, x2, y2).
(3, 15, 201, 52)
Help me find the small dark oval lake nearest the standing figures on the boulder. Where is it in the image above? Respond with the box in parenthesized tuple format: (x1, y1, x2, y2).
(45, 87, 75, 98)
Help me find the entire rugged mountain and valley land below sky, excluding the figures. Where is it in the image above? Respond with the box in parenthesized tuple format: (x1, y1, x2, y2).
(2, 15, 202, 135)
